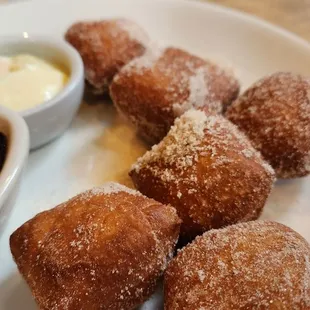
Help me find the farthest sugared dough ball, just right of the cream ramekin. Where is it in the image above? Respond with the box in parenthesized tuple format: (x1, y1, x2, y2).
(65, 19, 148, 94)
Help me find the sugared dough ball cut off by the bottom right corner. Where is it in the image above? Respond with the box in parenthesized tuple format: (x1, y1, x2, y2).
(164, 221, 310, 310)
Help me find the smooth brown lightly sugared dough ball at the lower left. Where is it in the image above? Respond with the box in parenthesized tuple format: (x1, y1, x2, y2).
(10, 183, 180, 310)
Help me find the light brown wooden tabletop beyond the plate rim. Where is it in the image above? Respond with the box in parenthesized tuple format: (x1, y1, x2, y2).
(205, 0, 310, 41)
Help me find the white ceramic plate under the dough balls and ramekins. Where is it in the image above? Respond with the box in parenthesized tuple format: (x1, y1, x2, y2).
(0, 0, 310, 310)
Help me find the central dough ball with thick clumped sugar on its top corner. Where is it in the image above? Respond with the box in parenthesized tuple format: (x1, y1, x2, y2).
(129, 110, 274, 240)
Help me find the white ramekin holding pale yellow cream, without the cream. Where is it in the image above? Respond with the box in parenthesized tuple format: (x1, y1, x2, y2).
(0, 34, 84, 149)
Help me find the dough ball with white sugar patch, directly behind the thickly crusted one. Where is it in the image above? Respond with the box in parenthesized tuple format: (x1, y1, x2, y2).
(110, 47, 239, 144)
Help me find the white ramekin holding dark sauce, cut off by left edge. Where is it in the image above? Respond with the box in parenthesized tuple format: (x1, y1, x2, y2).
(0, 106, 29, 234)
